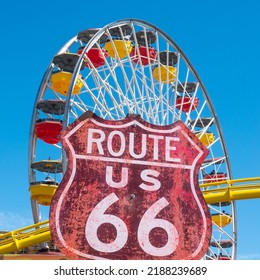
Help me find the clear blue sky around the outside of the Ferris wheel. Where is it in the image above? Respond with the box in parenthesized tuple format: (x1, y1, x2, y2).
(0, 0, 260, 259)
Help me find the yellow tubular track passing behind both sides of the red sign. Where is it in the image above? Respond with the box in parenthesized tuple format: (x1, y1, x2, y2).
(0, 177, 260, 254)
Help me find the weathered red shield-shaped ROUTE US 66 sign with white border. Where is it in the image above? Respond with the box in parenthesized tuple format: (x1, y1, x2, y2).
(50, 112, 211, 260)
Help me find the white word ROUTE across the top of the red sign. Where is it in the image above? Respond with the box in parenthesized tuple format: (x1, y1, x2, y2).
(87, 128, 181, 164)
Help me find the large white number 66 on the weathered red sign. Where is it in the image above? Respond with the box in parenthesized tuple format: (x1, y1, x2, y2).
(85, 193, 179, 257)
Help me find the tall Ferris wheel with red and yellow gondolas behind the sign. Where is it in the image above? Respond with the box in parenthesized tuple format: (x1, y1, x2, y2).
(28, 19, 236, 259)
